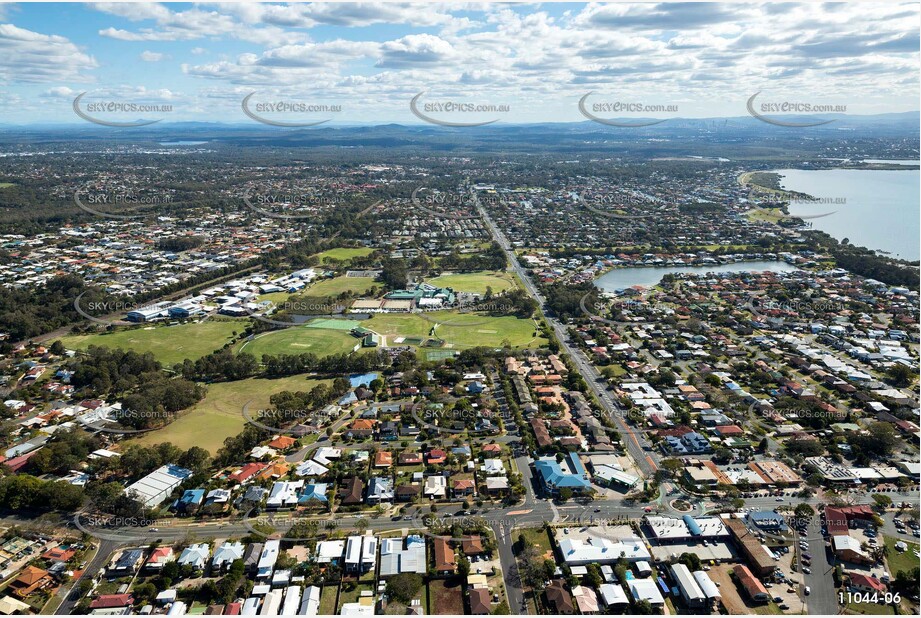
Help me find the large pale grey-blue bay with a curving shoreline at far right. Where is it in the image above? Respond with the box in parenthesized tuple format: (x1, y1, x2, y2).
(775, 162, 921, 260)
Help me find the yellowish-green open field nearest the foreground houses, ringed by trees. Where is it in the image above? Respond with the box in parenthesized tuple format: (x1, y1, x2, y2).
(129, 375, 330, 455)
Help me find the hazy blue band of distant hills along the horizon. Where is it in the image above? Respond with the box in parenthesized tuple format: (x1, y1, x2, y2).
(0, 112, 921, 156)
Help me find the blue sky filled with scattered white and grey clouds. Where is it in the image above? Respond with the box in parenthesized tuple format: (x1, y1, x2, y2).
(0, 2, 921, 125)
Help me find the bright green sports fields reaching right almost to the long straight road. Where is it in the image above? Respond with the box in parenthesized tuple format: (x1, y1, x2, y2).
(361, 311, 547, 348)
